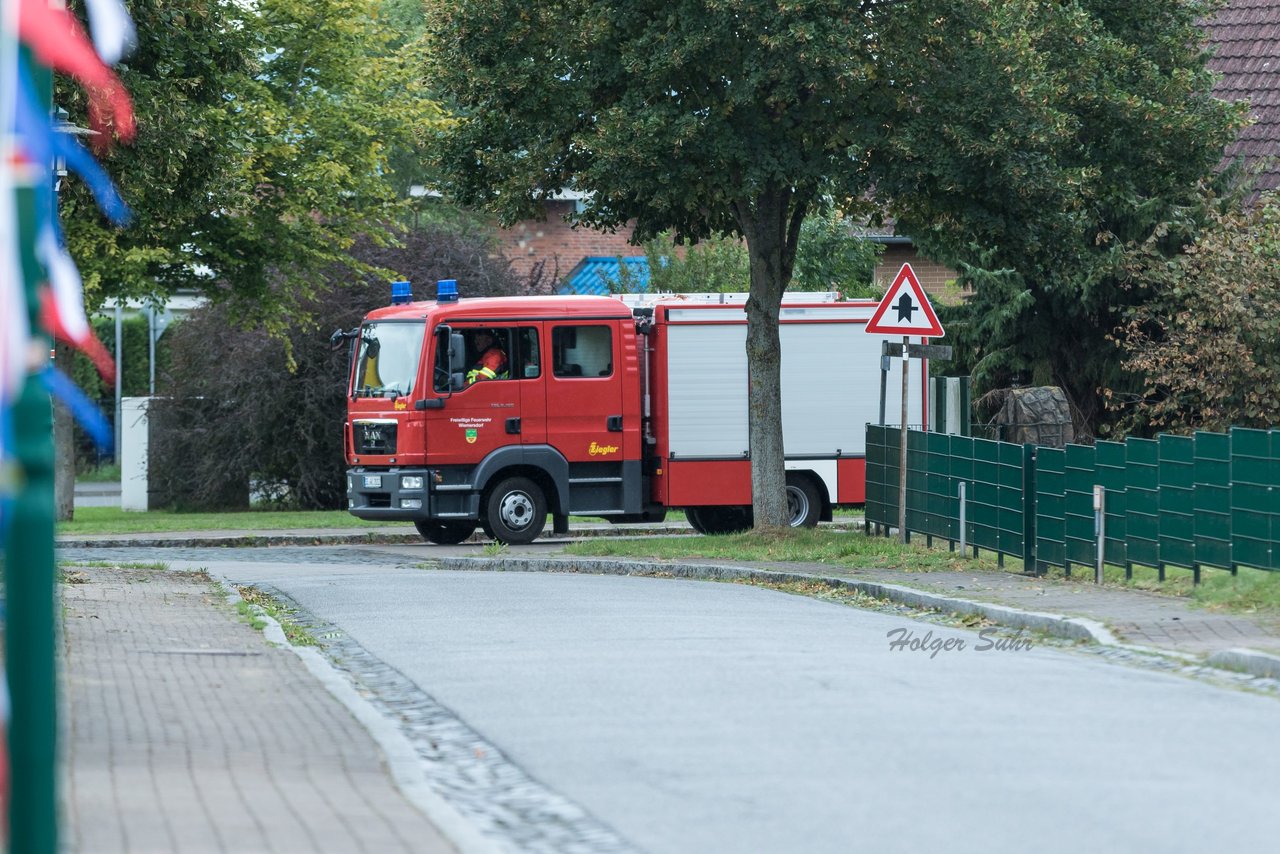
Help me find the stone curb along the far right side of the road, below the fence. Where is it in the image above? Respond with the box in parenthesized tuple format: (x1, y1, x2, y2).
(439, 557, 1280, 679)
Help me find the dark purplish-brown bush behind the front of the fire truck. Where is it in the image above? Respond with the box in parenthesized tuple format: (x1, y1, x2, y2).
(151, 224, 529, 510)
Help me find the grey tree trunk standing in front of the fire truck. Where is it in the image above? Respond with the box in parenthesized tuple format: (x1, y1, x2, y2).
(737, 187, 804, 530)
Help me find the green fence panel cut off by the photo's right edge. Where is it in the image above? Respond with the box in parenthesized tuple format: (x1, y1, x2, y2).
(1231, 429, 1280, 570)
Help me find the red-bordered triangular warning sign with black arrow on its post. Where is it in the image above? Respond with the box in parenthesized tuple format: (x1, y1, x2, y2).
(867, 264, 945, 543)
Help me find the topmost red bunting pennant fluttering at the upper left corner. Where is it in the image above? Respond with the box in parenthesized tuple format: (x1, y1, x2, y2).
(18, 0, 136, 149)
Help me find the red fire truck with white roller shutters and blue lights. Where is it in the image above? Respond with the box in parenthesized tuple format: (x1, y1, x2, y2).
(345, 280, 928, 544)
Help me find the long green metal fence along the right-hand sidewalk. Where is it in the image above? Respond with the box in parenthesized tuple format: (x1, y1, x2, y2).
(867, 425, 1280, 580)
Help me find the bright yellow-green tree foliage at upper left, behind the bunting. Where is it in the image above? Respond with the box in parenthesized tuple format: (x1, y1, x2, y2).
(58, 0, 440, 329)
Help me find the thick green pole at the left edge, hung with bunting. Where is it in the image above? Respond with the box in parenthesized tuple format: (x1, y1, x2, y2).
(4, 41, 58, 854)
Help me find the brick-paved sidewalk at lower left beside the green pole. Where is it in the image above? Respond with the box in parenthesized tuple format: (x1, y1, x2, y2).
(61, 567, 454, 854)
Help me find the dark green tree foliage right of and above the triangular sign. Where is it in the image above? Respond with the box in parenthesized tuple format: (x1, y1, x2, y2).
(874, 0, 1243, 430)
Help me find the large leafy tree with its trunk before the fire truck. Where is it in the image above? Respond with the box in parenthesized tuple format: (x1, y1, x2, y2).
(429, 0, 911, 528)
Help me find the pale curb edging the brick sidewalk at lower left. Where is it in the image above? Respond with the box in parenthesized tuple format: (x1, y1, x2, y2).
(214, 575, 503, 854)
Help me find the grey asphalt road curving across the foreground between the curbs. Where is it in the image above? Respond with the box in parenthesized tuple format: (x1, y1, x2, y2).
(162, 549, 1280, 853)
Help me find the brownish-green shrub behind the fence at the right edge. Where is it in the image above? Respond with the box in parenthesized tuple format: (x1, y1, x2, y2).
(1108, 195, 1280, 433)
